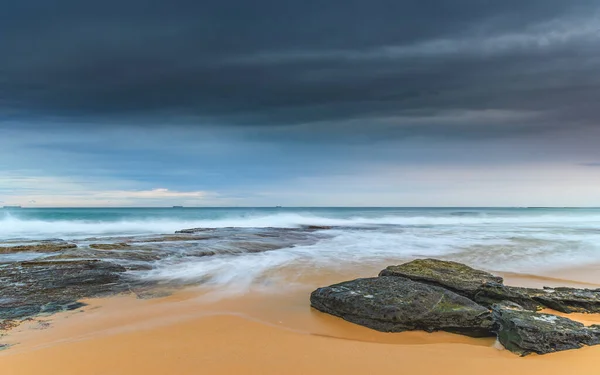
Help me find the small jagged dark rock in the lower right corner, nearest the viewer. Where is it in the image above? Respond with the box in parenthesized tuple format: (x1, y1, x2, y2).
(492, 303, 600, 356)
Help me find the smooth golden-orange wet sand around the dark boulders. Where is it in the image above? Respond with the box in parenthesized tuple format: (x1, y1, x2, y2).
(0, 269, 600, 375)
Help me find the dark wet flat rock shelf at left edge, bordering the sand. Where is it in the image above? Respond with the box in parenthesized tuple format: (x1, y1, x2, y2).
(0, 260, 128, 323)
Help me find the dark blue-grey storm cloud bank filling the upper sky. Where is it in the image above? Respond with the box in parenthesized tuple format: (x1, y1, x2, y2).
(0, 0, 600, 138)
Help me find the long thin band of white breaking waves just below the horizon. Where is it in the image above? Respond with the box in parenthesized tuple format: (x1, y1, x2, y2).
(0, 212, 600, 239)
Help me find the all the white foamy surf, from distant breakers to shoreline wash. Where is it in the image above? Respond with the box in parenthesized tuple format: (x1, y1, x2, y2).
(0, 209, 600, 291)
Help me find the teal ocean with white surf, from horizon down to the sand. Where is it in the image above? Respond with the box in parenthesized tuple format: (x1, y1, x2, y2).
(0, 208, 600, 289)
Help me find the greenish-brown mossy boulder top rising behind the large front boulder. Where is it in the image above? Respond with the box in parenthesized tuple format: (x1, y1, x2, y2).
(379, 259, 503, 299)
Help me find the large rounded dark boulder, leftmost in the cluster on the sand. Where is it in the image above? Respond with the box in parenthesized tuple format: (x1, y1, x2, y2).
(310, 276, 492, 337)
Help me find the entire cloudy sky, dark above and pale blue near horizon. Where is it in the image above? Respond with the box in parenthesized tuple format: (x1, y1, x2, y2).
(0, 0, 600, 207)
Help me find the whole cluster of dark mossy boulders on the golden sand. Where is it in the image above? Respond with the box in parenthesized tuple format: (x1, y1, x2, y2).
(310, 259, 600, 356)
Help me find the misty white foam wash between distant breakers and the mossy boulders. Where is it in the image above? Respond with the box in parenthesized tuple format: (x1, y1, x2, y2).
(145, 225, 600, 292)
